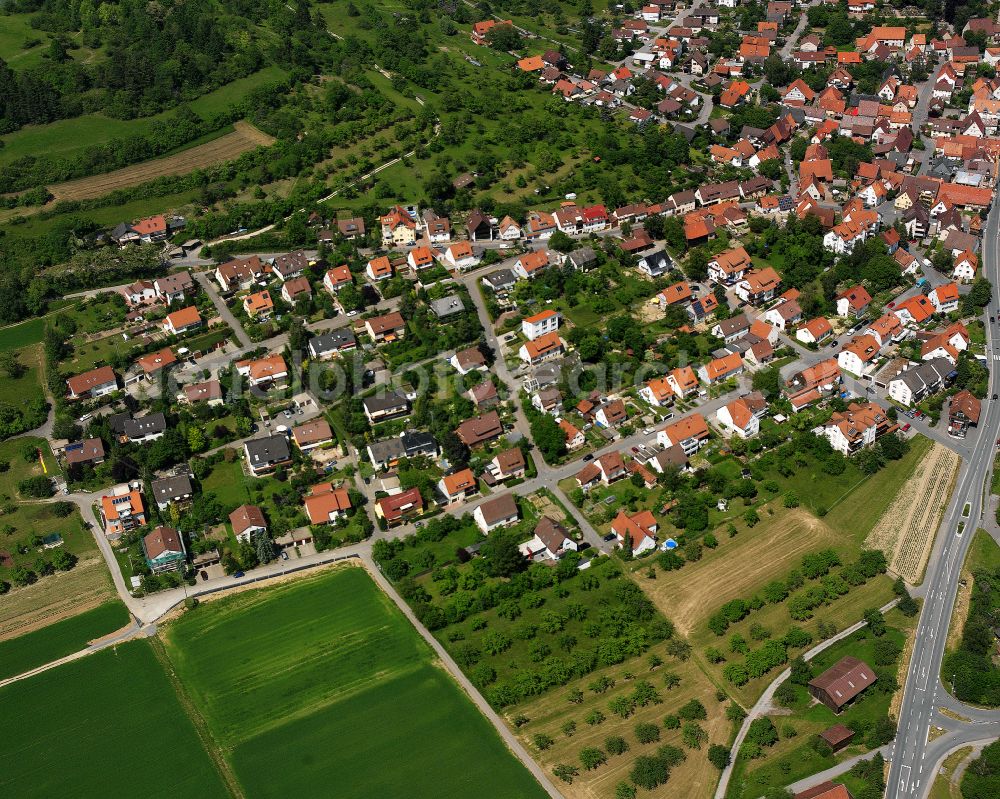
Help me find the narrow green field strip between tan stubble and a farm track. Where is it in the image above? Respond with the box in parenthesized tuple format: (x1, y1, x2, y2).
(0, 600, 129, 679)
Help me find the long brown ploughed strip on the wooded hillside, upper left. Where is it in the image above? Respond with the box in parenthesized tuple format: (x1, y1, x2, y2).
(48, 122, 275, 200)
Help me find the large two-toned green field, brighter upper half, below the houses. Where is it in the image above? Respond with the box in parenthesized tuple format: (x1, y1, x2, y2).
(163, 568, 544, 798)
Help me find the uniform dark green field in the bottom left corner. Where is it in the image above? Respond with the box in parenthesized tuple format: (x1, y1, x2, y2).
(0, 641, 228, 799)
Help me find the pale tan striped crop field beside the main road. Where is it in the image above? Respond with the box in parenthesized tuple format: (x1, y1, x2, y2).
(865, 444, 959, 585)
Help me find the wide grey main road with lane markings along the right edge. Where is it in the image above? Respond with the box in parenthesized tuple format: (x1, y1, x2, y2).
(886, 205, 1000, 799)
